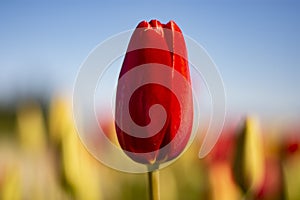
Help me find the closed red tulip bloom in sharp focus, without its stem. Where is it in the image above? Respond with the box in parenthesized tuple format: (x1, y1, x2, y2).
(115, 20, 193, 164)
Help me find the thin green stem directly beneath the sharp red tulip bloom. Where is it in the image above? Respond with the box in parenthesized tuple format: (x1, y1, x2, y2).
(148, 169, 160, 200)
